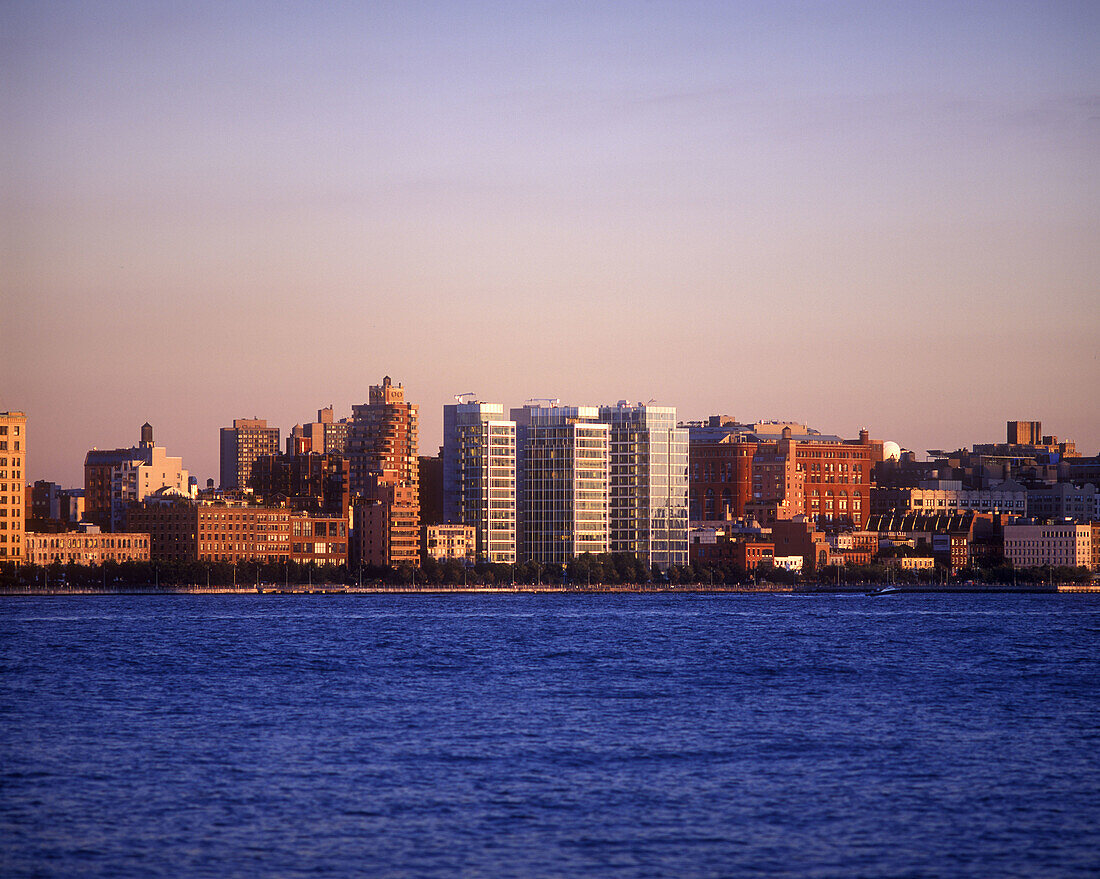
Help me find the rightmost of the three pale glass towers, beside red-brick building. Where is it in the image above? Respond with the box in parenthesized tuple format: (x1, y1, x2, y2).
(600, 400, 689, 570)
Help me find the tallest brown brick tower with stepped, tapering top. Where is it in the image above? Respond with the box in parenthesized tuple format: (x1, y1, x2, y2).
(348, 375, 420, 565)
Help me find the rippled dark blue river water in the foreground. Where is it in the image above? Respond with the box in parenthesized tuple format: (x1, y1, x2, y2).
(0, 595, 1100, 877)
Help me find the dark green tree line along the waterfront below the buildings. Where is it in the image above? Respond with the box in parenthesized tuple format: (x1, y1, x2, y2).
(0, 552, 1090, 593)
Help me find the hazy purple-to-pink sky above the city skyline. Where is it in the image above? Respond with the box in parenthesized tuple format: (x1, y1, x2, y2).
(0, 0, 1100, 486)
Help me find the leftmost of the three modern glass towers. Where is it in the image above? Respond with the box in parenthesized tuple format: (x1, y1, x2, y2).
(443, 403, 516, 563)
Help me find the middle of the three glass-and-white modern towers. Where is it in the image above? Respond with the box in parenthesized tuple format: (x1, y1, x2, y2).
(512, 403, 611, 564)
